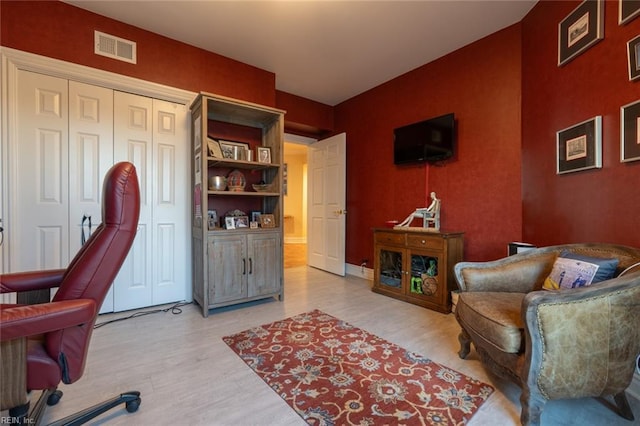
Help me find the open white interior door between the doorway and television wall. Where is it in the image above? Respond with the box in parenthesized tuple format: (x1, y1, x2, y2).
(307, 133, 347, 276)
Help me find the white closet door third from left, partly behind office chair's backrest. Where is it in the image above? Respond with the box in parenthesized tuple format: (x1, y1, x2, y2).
(113, 91, 153, 311)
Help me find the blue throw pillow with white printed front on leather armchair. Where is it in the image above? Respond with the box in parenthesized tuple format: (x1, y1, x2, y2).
(542, 251, 618, 290)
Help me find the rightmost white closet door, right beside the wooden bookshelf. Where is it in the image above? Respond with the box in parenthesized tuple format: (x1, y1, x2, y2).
(150, 99, 191, 305)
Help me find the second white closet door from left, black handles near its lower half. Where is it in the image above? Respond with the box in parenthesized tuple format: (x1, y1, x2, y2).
(69, 81, 113, 313)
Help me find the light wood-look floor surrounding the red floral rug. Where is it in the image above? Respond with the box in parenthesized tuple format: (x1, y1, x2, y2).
(38, 267, 640, 426)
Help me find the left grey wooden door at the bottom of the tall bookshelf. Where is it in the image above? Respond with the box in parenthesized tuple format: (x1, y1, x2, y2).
(208, 234, 249, 305)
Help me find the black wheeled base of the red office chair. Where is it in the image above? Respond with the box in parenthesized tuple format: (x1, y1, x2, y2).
(9, 389, 142, 426)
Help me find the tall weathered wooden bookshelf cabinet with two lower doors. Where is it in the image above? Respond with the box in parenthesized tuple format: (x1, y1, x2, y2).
(191, 93, 284, 317)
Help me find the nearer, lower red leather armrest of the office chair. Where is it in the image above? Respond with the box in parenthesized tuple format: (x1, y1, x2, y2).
(0, 299, 97, 342)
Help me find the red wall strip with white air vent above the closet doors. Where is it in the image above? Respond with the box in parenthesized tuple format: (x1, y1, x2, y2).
(0, 1, 275, 106)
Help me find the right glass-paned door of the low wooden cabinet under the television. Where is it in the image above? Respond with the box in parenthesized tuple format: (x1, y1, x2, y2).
(405, 250, 447, 303)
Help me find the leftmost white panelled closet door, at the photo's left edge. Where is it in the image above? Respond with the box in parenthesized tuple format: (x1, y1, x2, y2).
(12, 71, 69, 272)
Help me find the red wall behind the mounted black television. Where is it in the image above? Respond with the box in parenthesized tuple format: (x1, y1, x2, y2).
(335, 24, 522, 266)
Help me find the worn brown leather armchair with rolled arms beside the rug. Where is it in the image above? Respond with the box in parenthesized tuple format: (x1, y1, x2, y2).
(454, 244, 640, 425)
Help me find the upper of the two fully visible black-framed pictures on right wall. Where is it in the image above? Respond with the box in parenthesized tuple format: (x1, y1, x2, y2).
(558, 0, 604, 66)
